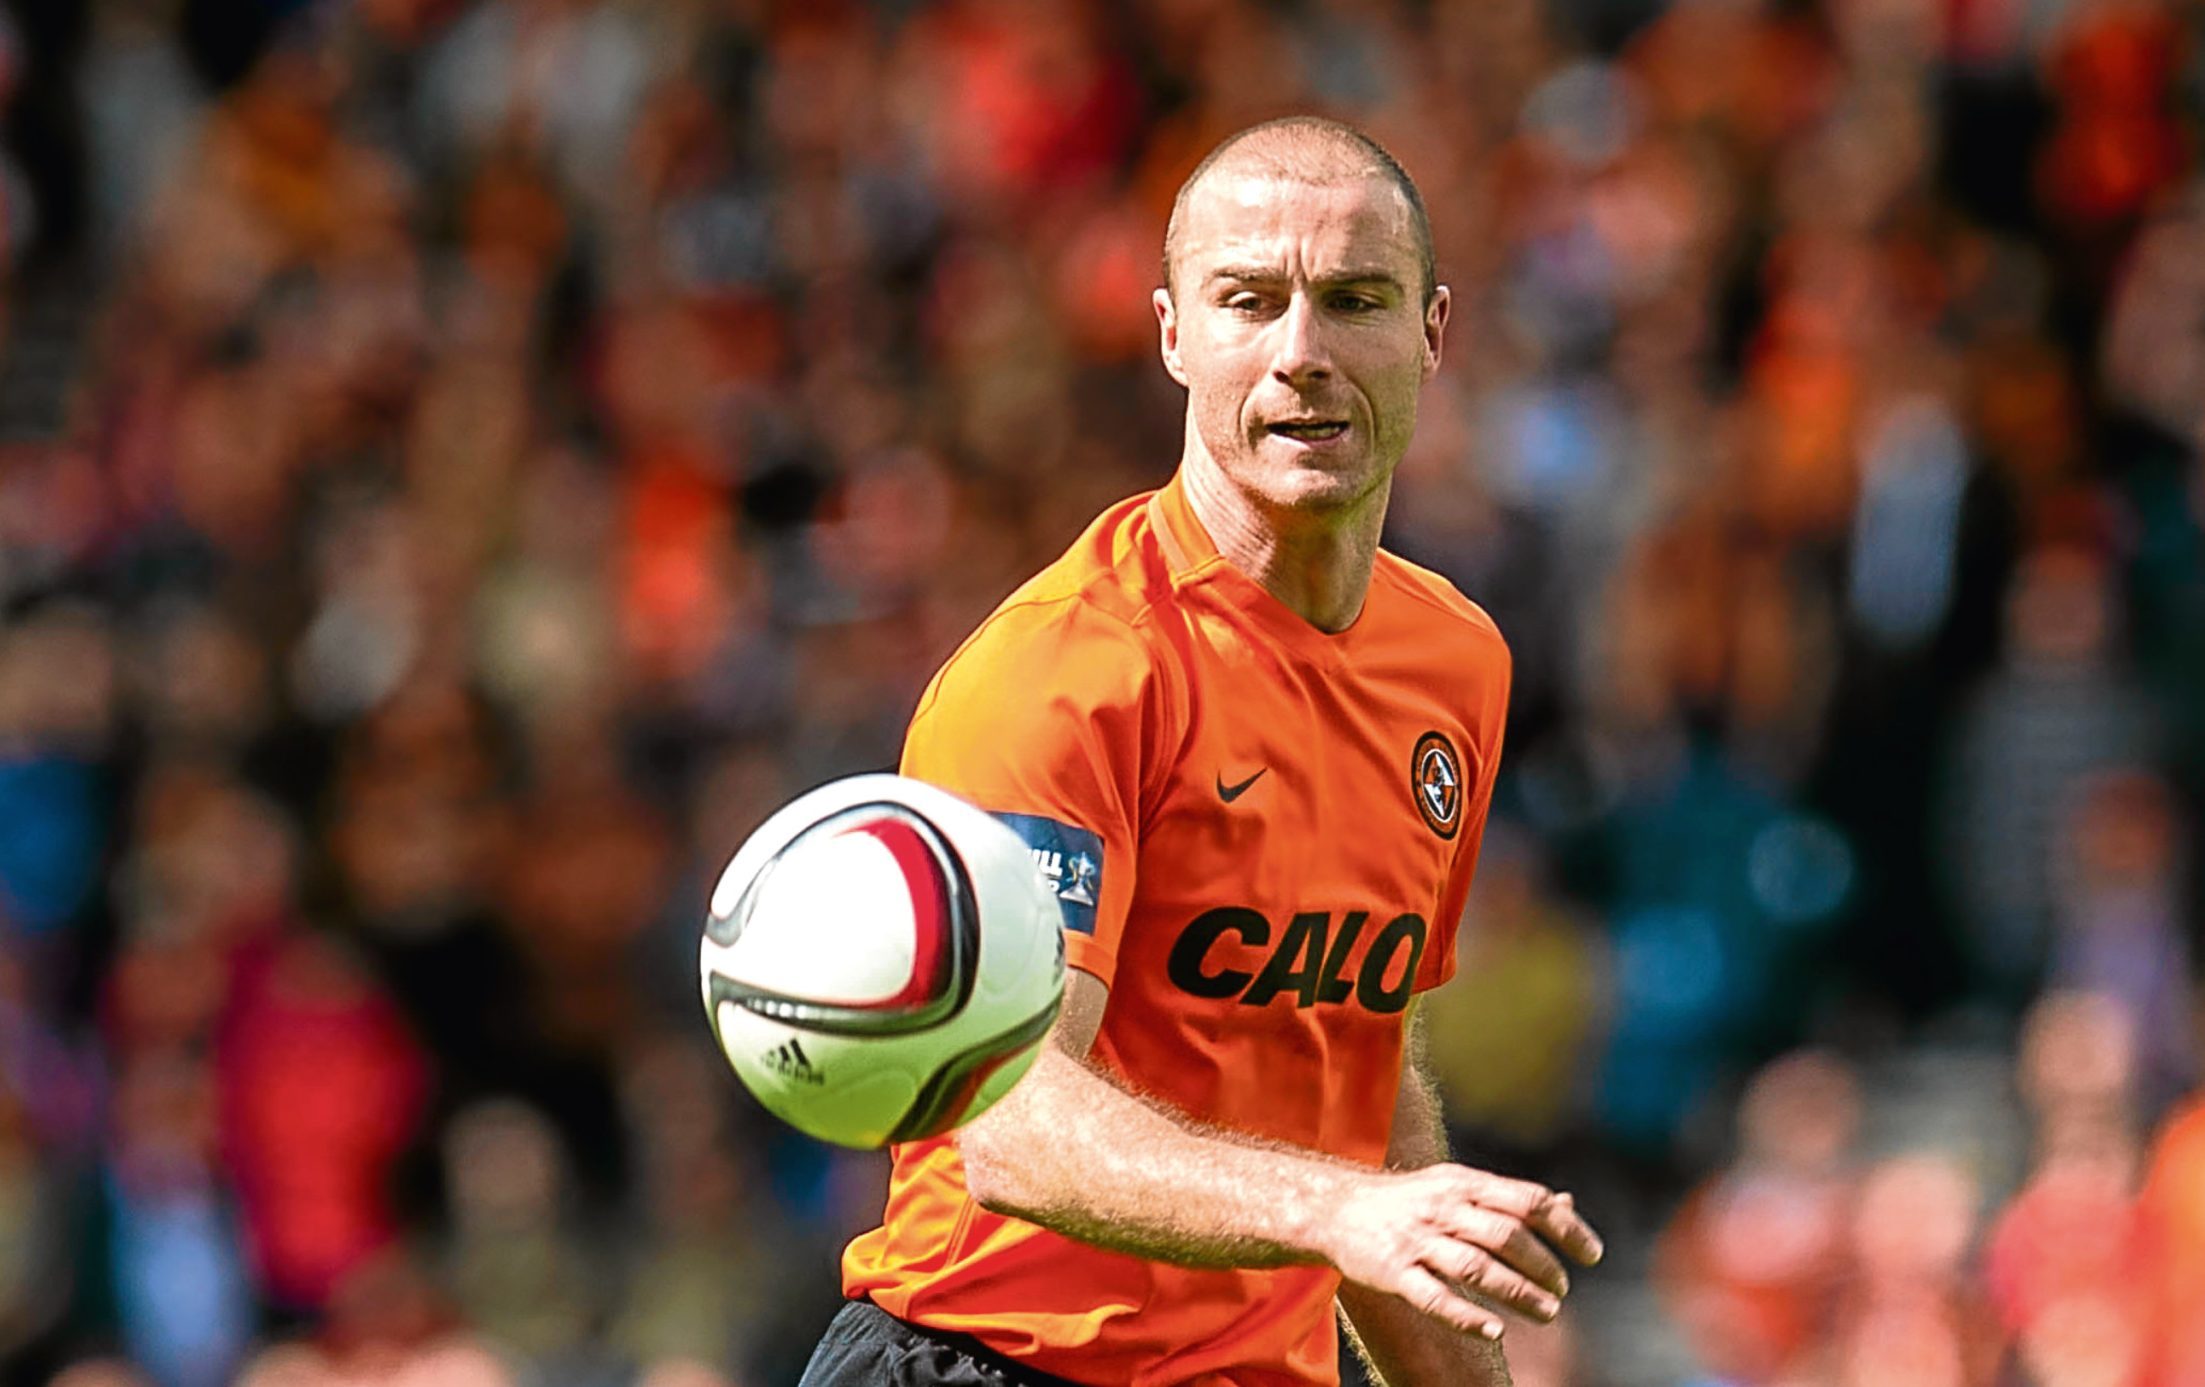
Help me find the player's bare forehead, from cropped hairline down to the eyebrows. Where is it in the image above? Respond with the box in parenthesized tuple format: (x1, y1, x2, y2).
(1177, 170, 1420, 284)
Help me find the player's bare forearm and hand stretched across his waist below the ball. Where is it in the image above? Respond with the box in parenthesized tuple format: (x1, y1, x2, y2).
(959, 970, 1599, 1334)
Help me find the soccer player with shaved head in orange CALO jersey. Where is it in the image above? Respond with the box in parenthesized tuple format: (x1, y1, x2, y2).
(805, 117, 1601, 1387)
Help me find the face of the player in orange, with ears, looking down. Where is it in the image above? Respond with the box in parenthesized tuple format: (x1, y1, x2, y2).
(1155, 170, 1449, 512)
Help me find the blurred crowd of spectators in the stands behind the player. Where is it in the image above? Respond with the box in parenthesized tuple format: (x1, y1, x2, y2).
(0, 0, 2205, 1387)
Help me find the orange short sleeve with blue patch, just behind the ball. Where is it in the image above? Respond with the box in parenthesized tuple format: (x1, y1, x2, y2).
(902, 598, 1164, 983)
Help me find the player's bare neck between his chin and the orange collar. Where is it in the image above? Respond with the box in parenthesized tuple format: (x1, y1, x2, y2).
(1180, 450, 1394, 633)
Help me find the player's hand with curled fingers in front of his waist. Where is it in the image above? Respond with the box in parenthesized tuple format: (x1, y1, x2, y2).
(1323, 1164, 1603, 1338)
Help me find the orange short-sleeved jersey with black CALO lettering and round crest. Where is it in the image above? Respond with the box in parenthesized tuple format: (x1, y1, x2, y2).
(842, 483, 1508, 1385)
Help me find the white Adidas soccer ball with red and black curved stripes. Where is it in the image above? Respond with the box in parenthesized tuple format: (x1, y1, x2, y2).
(697, 774, 1065, 1147)
